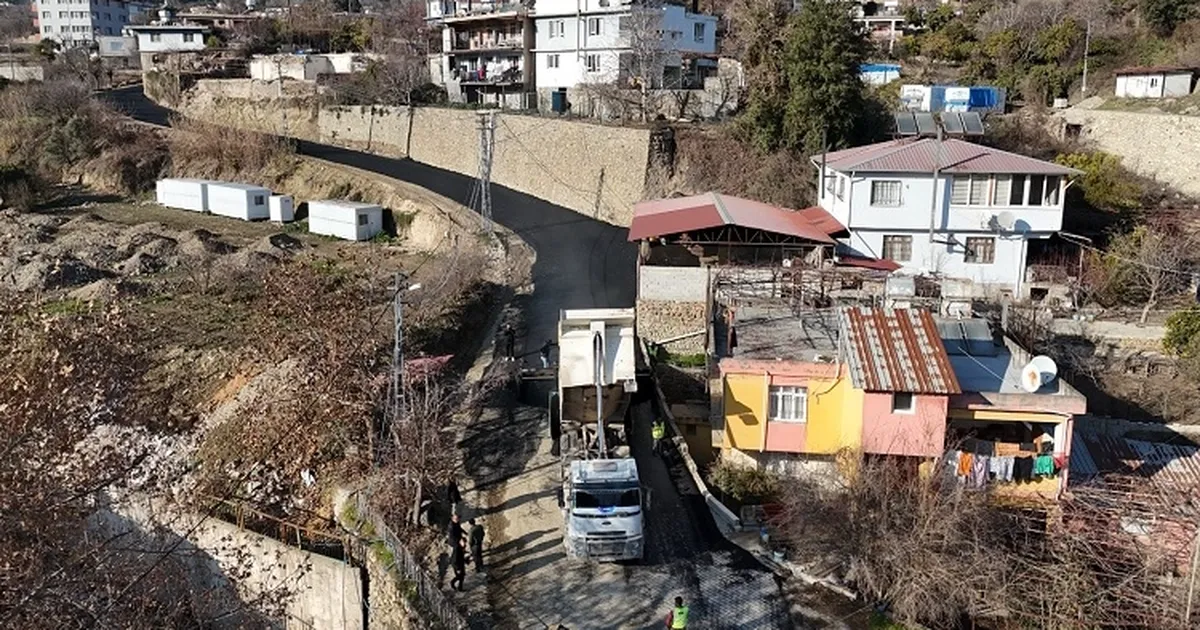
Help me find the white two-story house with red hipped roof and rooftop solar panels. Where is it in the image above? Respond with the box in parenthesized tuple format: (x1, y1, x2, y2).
(811, 138, 1080, 296)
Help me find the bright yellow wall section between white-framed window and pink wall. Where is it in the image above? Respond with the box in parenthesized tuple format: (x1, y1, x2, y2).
(804, 376, 863, 455)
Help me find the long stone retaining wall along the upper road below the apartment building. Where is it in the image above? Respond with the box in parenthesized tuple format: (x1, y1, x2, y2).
(162, 79, 649, 226)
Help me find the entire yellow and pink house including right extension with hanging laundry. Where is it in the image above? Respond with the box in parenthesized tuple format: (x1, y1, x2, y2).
(716, 305, 1087, 504)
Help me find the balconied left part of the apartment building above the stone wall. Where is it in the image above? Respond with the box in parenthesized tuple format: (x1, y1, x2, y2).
(427, 0, 534, 109)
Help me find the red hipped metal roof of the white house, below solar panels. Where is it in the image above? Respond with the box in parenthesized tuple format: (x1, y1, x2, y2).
(812, 138, 1081, 175)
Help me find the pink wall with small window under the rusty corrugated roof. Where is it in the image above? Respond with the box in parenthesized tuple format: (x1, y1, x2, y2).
(863, 392, 948, 457)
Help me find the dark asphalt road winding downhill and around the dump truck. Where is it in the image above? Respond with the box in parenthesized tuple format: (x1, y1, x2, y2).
(104, 85, 790, 629)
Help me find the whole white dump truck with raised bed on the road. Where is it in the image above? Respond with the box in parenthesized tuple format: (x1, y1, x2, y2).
(550, 308, 644, 562)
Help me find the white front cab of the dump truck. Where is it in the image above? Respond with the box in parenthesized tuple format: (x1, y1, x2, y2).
(565, 460, 644, 562)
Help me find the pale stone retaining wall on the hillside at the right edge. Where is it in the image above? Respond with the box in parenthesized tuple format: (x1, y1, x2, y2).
(1060, 108, 1200, 197)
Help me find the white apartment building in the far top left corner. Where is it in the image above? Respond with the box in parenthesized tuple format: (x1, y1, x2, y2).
(34, 0, 154, 48)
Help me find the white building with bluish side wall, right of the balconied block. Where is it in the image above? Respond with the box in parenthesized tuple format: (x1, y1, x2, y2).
(534, 0, 716, 97)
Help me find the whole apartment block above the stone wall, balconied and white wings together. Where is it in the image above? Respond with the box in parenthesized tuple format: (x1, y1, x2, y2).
(426, 0, 716, 110)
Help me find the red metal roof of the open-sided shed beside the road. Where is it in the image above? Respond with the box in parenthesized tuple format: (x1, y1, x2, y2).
(629, 192, 846, 244)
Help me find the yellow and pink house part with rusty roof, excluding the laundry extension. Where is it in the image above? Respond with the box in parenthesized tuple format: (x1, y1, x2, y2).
(718, 306, 961, 474)
